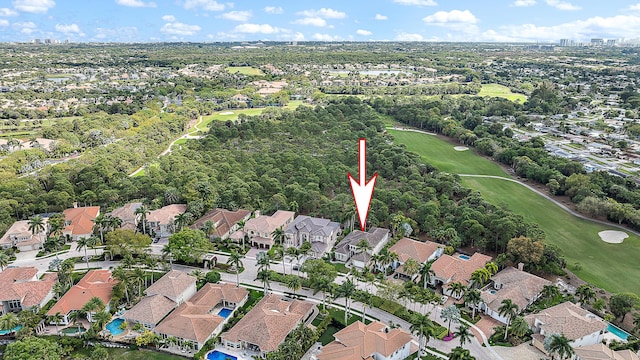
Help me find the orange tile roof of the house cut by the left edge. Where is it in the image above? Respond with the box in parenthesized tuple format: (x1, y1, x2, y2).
(0, 267, 58, 308)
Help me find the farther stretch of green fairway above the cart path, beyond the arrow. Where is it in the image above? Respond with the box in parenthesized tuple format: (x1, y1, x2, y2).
(387, 129, 507, 176)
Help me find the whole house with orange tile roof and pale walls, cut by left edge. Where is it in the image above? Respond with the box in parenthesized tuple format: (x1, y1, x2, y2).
(0, 267, 58, 314)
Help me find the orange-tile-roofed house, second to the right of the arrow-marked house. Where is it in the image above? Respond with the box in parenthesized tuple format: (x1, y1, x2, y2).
(431, 253, 491, 299)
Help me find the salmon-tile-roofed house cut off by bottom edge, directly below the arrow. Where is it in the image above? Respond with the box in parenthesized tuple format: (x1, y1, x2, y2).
(318, 321, 412, 360)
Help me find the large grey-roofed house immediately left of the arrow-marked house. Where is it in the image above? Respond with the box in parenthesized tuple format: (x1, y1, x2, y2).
(284, 215, 340, 258)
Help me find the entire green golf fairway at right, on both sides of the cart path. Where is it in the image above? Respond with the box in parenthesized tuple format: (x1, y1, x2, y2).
(388, 130, 640, 294)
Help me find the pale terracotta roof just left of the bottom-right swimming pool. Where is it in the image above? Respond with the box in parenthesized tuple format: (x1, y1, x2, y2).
(524, 301, 607, 341)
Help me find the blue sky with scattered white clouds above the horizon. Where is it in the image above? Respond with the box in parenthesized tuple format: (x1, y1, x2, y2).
(0, 0, 640, 42)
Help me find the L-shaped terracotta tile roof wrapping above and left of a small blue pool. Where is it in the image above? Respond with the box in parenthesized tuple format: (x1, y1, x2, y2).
(154, 284, 249, 344)
